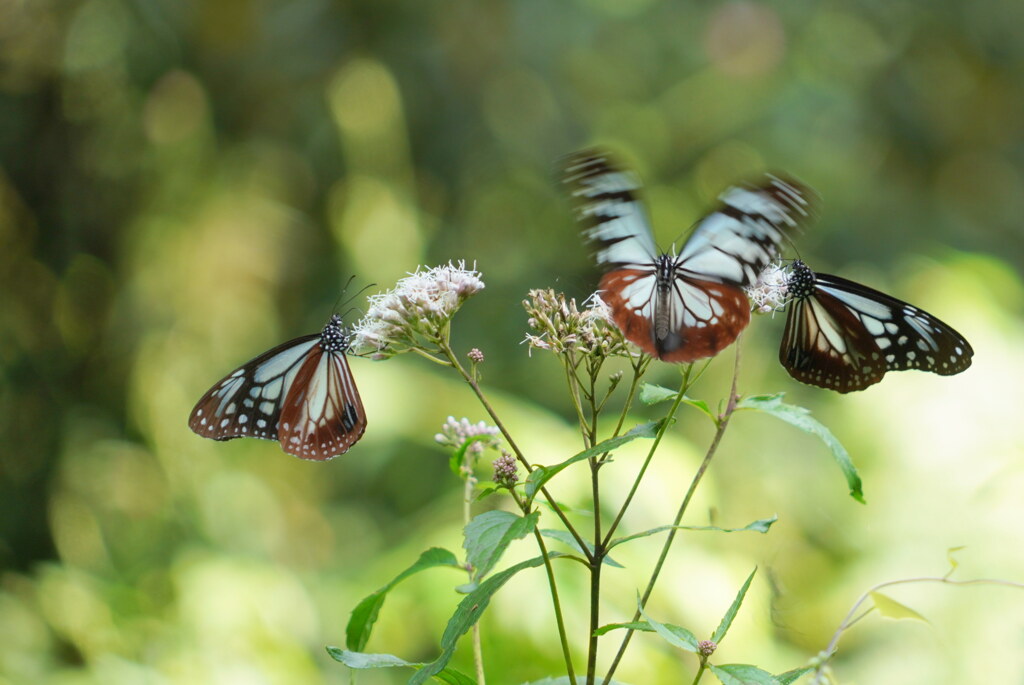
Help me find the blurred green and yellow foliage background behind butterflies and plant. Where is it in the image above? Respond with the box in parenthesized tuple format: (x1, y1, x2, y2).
(0, 0, 1024, 685)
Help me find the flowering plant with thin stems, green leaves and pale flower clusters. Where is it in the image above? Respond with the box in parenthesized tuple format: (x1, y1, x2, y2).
(328, 262, 1007, 685)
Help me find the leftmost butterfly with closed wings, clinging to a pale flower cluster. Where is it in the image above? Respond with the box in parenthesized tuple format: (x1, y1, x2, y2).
(188, 314, 367, 461)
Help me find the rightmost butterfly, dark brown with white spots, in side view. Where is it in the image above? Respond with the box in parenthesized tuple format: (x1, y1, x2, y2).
(778, 260, 974, 392)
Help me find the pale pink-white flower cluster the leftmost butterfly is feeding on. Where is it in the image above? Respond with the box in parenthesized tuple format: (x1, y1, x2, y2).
(352, 261, 483, 358)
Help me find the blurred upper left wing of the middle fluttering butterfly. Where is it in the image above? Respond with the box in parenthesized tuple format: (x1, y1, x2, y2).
(562, 149, 657, 269)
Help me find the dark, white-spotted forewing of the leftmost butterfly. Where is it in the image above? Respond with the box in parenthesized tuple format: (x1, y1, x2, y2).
(188, 334, 321, 440)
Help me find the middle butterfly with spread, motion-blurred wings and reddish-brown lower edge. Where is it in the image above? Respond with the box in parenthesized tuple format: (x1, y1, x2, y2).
(563, 149, 810, 362)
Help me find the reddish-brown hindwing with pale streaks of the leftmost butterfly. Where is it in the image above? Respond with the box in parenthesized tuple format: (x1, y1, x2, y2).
(279, 350, 367, 461)
